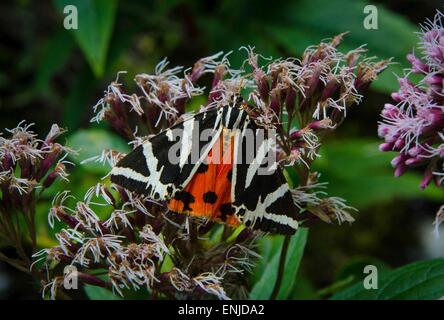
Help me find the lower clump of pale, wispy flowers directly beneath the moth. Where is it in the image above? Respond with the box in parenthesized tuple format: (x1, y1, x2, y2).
(35, 184, 257, 299)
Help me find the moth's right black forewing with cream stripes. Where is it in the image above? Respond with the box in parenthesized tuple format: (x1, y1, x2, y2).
(231, 118, 298, 234)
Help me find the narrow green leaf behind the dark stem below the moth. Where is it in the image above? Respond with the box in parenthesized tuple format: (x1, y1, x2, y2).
(250, 228, 308, 300)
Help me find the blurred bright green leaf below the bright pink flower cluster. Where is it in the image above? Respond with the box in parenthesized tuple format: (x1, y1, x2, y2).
(315, 139, 443, 209)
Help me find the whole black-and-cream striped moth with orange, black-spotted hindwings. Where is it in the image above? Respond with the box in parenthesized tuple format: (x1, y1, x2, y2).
(110, 102, 298, 234)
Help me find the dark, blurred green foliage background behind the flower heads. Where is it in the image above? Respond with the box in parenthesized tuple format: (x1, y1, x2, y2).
(0, 0, 444, 299)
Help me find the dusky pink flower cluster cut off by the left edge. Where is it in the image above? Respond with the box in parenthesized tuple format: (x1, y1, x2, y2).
(0, 121, 75, 273)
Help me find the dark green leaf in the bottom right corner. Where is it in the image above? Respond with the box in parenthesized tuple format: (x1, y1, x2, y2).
(332, 259, 444, 300)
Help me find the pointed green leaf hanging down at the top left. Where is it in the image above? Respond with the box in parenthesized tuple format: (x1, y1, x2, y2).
(54, 0, 117, 77)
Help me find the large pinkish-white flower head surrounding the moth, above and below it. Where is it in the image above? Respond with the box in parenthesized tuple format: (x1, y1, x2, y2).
(36, 35, 389, 299)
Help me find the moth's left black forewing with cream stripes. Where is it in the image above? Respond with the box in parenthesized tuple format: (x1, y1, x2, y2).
(110, 109, 222, 200)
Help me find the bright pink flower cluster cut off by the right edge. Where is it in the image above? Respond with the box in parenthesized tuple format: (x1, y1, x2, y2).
(378, 12, 444, 189)
